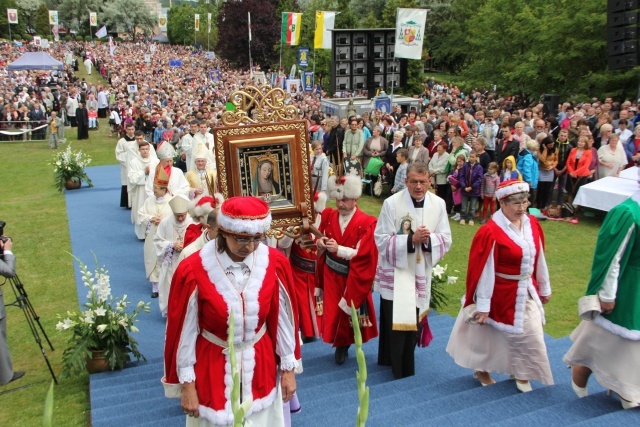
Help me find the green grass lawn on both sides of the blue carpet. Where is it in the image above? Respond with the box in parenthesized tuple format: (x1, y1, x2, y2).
(0, 67, 601, 426)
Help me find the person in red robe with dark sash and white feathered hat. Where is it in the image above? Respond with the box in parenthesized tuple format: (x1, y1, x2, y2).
(317, 176, 378, 365)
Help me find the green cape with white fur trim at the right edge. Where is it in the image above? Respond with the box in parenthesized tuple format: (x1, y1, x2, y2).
(587, 198, 640, 340)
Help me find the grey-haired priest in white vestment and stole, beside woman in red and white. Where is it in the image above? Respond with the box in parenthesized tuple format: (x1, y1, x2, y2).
(374, 162, 451, 378)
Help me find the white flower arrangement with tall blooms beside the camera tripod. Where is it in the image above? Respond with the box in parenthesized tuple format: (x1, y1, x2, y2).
(56, 260, 150, 377)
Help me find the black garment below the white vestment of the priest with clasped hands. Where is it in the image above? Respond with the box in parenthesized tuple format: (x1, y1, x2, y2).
(378, 298, 418, 379)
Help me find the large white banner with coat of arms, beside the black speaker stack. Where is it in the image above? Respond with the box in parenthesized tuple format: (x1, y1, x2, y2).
(394, 8, 427, 59)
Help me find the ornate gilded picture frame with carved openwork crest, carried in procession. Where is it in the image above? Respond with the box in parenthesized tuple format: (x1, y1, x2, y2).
(215, 86, 314, 239)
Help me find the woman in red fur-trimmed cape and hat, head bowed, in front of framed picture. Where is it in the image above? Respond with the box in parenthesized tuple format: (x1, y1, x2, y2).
(162, 197, 300, 427)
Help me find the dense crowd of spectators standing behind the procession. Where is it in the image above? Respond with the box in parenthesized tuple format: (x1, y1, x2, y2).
(5, 38, 640, 221)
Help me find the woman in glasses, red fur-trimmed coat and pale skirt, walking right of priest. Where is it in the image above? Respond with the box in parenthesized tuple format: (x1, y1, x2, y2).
(447, 180, 553, 392)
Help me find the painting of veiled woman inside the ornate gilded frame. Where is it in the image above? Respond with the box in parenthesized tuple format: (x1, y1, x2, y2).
(238, 144, 295, 208)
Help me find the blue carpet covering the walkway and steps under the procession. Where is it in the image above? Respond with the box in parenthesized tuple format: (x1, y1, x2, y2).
(66, 166, 640, 427)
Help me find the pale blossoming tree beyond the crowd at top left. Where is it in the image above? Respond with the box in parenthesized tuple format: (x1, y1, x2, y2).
(104, 0, 157, 39)
